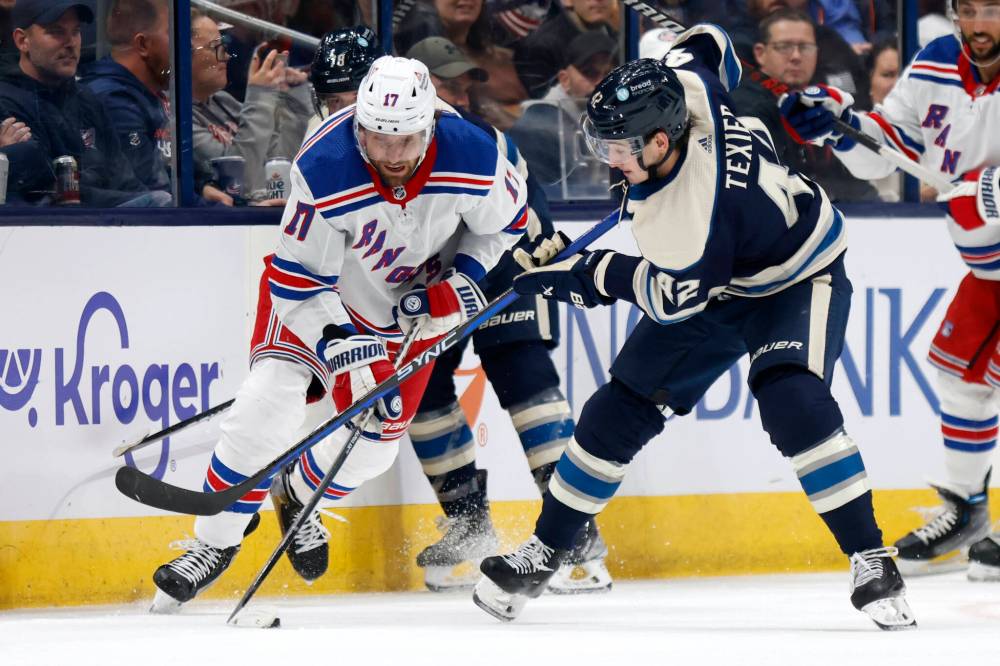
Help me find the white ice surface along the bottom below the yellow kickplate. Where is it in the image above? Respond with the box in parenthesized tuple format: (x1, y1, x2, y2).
(0, 573, 1000, 666)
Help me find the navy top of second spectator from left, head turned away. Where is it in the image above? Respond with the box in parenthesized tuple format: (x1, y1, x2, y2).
(80, 57, 171, 192)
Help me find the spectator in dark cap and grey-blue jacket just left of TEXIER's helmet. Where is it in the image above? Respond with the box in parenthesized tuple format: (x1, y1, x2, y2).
(509, 30, 618, 198)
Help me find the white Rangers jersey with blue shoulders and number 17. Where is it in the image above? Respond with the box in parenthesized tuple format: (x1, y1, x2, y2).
(268, 106, 527, 349)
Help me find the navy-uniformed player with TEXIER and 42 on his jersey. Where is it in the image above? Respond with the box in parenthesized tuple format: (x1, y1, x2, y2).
(474, 25, 915, 629)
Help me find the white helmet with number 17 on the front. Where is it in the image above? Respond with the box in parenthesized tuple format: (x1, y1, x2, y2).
(354, 56, 437, 159)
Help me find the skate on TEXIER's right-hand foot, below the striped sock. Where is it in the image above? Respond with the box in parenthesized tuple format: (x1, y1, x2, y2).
(851, 548, 917, 631)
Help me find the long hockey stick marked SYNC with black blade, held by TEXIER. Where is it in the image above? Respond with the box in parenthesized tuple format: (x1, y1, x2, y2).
(115, 202, 624, 516)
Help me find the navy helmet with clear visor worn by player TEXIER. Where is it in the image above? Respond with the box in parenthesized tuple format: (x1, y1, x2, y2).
(583, 58, 688, 162)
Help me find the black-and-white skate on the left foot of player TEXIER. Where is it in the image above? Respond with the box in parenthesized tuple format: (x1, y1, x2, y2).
(472, 535, 568, 622)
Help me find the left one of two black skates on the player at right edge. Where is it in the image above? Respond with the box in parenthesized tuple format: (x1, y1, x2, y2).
(895, 486, 990, 576)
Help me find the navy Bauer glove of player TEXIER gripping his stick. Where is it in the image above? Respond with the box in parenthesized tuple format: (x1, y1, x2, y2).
(514, 250, 615, 308)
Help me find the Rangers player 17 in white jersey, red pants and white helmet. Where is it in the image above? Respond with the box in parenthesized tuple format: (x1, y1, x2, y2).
(154, 56, 527, 611)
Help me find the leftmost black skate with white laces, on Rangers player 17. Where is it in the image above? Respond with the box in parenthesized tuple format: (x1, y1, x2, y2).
(149, 513, 260, 615)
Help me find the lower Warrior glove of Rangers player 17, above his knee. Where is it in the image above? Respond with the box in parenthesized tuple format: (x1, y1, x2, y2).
(319, 335, 403, 421)
